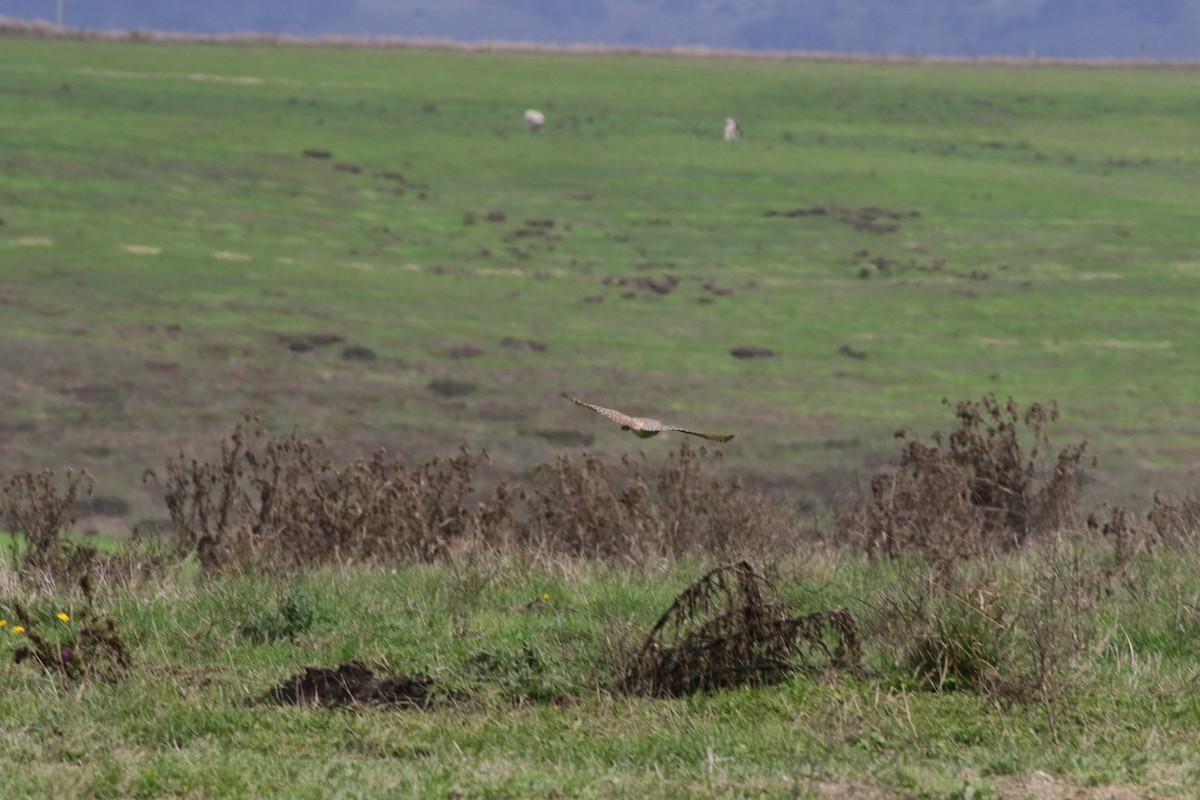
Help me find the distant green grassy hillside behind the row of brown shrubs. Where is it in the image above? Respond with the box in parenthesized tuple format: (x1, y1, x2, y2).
(0, 40, 1200, 518)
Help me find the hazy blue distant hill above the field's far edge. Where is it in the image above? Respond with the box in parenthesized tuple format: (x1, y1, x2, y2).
(0, 0, 1200, 60)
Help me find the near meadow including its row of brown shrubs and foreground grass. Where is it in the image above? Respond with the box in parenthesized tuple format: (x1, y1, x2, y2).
(0, 396, 1200, 796)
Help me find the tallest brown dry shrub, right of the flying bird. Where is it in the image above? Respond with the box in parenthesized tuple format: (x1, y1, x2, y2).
(838, 395, 1087, 570)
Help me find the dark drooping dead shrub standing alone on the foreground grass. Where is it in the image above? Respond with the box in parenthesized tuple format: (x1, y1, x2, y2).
(623, 561, 860, 697)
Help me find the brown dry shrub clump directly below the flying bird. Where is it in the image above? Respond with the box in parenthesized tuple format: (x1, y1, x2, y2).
(518, 444, 792, 561)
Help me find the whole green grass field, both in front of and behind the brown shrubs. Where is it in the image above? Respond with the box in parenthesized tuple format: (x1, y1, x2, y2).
(0, 38, 1200, 800)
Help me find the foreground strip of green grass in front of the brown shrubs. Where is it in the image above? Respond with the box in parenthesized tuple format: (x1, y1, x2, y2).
(0, 548, 1200, 800)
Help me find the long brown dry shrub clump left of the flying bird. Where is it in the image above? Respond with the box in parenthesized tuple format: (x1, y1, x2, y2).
(150, 417, 510, 569)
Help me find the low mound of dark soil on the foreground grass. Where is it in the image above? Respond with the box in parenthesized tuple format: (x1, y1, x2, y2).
(262, 661, 445, 710)
